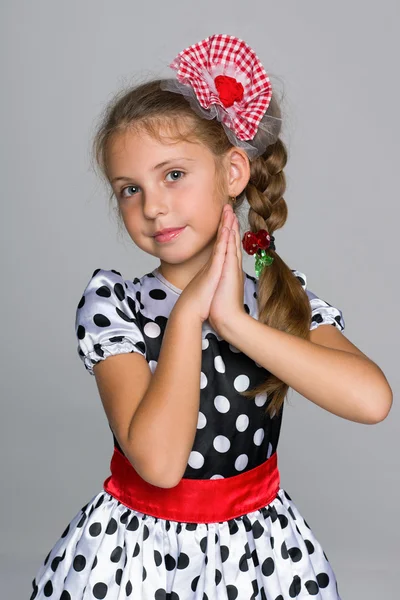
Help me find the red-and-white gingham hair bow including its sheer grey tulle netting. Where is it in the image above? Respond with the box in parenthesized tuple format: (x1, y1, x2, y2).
(161, 34, 281, 157)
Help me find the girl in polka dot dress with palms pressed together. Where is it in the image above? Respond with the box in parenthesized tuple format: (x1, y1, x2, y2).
(31, 35, 392, 600)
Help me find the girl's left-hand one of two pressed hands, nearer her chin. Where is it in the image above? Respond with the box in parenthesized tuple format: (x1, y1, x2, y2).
(174, 204, 232, 322)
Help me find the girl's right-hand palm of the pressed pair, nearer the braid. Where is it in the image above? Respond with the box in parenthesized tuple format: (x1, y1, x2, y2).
(208, 205, 246, 337)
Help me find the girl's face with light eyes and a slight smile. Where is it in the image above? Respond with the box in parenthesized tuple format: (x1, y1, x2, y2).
(108, 132, 228, 271)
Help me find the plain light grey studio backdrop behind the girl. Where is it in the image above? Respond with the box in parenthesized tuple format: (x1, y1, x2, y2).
(0, 0, 400, 600)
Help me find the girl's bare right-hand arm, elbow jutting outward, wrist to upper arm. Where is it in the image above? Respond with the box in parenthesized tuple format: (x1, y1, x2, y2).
(221, 313, 393, 424)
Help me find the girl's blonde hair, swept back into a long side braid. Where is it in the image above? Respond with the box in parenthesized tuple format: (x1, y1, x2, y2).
(93, 79, 311, 415)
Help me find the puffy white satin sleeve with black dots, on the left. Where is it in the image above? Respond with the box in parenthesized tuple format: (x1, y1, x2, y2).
(75, 269, 146, 375)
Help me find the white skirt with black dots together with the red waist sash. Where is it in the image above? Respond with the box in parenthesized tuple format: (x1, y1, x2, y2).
(30, 448, 341, 600)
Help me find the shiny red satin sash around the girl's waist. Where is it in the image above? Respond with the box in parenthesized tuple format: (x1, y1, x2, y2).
(103, 447, 280, 523)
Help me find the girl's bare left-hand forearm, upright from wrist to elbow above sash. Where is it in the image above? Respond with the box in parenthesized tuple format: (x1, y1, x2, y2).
(128, 307, 202, 487)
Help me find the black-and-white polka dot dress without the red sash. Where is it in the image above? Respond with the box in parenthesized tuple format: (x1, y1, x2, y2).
(31, 269, 345, 600)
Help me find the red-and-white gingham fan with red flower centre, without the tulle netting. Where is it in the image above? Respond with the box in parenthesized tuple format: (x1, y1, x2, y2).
(169, 34, 272, 140)
